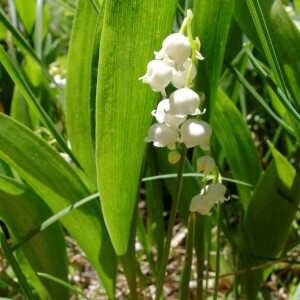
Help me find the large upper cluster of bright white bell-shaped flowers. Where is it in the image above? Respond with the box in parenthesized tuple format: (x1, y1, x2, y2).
(140, 12, 212, 150)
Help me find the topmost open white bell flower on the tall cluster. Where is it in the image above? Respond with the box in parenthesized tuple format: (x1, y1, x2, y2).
(154, 33, 191, 69)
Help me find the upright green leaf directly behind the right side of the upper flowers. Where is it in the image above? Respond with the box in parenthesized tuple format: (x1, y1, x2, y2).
(193, 0, 233, 110)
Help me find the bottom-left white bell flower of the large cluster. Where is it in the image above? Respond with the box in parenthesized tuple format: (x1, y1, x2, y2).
(145, 123, 179, 150)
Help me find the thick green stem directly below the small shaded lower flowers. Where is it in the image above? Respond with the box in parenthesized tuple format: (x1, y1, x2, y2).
(179, 212, 195, 300)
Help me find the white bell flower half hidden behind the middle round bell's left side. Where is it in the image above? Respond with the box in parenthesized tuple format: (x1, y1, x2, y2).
(152, 99, 187, 128)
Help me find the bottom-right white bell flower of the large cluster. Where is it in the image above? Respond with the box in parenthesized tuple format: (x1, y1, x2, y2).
(180, 119, 212, 150)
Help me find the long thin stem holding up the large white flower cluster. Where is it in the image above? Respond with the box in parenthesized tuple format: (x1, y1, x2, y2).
(155, 145, 187, 300)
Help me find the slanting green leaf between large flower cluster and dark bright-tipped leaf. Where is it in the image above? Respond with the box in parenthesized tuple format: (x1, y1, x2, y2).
(211, 89, 262, 208)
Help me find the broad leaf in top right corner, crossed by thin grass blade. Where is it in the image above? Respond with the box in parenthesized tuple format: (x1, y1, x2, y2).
(234, 0, 300, 108)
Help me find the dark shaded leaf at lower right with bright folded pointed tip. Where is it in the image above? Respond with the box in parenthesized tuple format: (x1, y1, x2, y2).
(240, 144, 300, 299)
